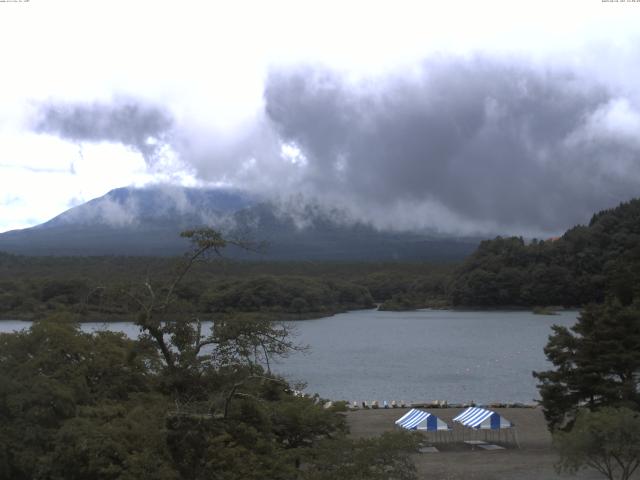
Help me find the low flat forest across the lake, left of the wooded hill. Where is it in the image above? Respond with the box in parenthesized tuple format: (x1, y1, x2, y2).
(0, 253, 453, 320)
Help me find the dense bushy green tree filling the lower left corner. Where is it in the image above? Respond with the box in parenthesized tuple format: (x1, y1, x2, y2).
(0, 316, 164, 480)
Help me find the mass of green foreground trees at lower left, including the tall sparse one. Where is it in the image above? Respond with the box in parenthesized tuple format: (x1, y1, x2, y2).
(0, 231, 414, 480)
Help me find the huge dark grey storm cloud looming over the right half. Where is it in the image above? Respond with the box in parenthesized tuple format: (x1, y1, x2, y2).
(265, 59, 640, 235)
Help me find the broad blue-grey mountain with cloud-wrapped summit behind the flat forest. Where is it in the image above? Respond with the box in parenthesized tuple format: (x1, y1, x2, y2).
(0, 186, 478, 261)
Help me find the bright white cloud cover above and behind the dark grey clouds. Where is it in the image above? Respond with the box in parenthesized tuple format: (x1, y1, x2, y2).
(0, 0, 640, 231)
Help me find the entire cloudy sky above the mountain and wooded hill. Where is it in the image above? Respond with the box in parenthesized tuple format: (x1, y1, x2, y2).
(0, 0, 640, 237)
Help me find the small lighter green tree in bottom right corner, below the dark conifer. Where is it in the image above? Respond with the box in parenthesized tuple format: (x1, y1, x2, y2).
(554, 407, 640, 480)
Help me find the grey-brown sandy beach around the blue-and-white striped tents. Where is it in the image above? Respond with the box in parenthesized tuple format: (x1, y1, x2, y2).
(346, 408, 620, 480)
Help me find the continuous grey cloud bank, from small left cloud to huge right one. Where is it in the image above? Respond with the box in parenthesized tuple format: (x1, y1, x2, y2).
(27, 56, 640, 236)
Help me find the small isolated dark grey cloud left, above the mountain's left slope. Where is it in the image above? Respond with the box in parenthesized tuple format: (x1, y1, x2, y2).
(33, 100, 173, 164)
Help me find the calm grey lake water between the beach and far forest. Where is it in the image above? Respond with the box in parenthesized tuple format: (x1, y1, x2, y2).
(0, 310, 577, 403)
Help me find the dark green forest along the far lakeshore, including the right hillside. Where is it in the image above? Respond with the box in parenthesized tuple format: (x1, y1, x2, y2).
(0, 200, 640, 321)
